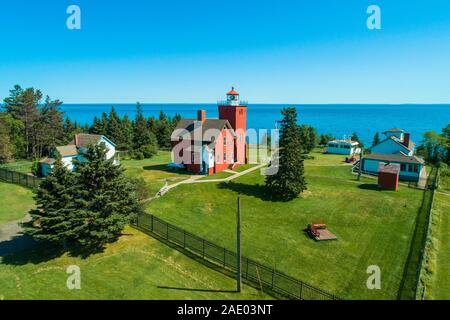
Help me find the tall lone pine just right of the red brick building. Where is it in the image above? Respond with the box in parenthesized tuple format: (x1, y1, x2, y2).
(266, 108, 306, 201)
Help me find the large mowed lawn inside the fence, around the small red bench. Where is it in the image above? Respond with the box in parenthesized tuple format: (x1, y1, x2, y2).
(147, 153, 423, 299)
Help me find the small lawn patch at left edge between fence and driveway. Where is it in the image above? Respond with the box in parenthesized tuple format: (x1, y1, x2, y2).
(0, 181, 34, 224)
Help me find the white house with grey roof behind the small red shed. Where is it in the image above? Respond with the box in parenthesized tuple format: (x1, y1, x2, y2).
(358, 128, 426, 181)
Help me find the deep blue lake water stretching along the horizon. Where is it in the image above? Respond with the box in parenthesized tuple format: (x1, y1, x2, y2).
(62, 104, 450, 145)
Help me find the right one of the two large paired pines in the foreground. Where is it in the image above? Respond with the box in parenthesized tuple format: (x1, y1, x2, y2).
(75, 143, 142, 248)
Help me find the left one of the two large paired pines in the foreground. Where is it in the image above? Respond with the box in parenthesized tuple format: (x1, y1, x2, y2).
(23, 158, 80, 245)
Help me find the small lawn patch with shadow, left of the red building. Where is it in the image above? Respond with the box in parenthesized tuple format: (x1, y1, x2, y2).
(121, 151, 190, 196)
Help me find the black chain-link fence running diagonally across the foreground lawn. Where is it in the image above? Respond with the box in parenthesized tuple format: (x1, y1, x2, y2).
(135, 213, 340, 300)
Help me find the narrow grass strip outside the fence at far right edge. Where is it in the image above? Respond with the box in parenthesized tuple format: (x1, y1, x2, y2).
(431, 193, 450, 300)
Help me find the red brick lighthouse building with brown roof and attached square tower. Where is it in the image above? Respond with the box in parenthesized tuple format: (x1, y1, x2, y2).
(172, 88, 247, 174)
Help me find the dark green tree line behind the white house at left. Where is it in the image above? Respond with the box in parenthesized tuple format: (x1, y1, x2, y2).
(0, 85, 181, 163)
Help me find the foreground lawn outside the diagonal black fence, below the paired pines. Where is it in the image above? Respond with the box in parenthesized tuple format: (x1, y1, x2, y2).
(0, 228, 270, 300)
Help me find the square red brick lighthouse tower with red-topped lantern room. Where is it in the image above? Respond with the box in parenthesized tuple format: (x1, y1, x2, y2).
(219, 87, 247, 164)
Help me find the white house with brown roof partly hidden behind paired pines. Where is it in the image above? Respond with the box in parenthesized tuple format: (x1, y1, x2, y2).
(39, 133, 119, 176)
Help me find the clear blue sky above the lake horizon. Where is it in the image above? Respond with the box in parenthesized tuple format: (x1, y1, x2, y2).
(0, 0, 450, 103)
